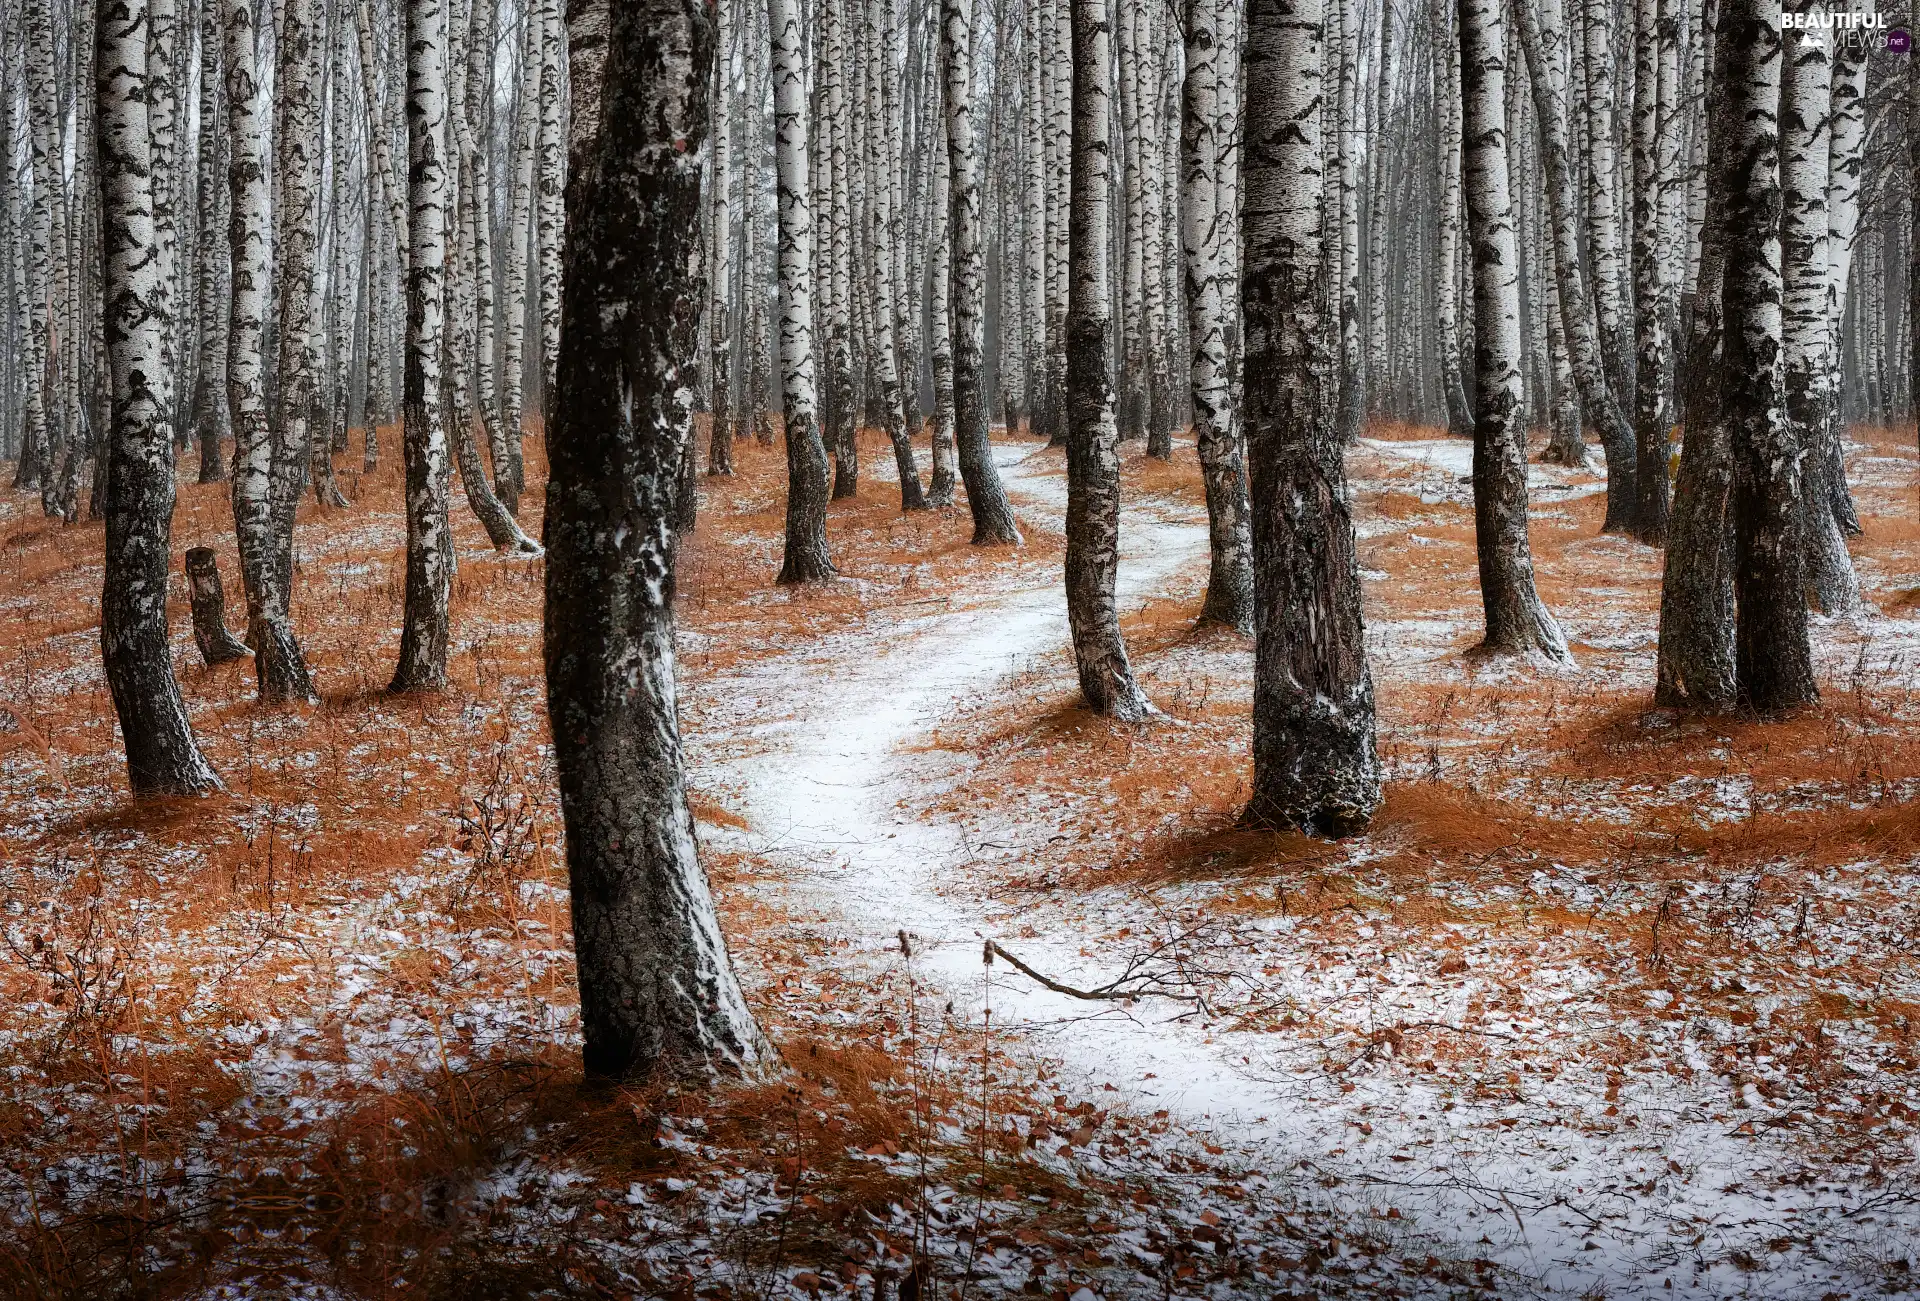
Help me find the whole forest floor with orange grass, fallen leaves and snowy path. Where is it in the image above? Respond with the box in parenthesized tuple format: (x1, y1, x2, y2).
(0, 428, 1920, 1301)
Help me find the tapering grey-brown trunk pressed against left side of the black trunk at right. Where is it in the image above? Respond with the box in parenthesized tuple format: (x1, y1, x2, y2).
(1653, 15, 1736, 712)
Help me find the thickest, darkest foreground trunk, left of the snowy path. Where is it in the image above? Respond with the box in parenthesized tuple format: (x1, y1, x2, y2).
(545, 0, 781, 1080)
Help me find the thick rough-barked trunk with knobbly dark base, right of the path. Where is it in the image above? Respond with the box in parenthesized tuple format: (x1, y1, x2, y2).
(1242, 0, 1380, 837)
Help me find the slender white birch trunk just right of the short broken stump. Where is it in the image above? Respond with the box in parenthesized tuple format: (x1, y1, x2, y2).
(227, 0, 317, 704)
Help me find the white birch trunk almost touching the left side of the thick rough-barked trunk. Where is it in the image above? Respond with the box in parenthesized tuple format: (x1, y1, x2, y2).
(1181, 0, 1254, 633)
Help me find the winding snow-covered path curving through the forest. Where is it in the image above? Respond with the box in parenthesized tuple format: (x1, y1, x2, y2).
(689, 445, 1910, 1297)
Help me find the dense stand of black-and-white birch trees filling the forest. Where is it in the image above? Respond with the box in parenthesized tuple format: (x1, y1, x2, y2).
(0, 0, 1920, 1073)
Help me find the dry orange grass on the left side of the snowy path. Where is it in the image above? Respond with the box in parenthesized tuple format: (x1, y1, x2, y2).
(0, 418, 1121, 1297)
